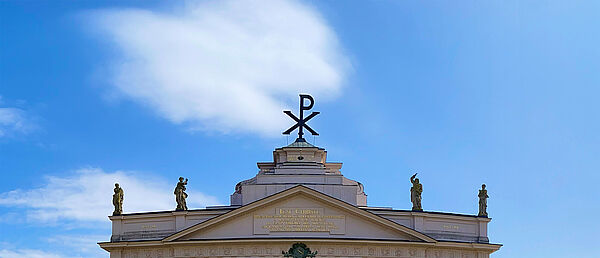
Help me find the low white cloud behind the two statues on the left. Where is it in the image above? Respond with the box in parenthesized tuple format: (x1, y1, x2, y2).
(0, 168, 219, 222)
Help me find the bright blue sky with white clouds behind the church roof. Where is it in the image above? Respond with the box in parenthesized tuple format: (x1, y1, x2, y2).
(0, 1, 600, 258)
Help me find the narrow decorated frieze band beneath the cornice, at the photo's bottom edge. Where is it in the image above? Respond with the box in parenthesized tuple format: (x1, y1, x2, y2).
(122, 243, 489, 258)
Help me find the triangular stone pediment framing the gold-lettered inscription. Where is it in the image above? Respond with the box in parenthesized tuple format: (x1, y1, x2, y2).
(163, 185, 435, 242)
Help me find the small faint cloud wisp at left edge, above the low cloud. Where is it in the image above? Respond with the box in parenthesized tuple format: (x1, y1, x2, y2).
(0, 107, 35, 137)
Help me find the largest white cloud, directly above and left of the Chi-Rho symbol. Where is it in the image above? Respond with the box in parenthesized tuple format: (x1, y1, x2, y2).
(91, 0, 350, 137)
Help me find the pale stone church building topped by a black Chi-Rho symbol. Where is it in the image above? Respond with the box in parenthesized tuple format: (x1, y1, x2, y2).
(99, 95, 501, 258)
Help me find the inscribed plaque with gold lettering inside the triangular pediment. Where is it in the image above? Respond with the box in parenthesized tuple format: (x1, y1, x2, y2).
(254, 208, 346, 235)
